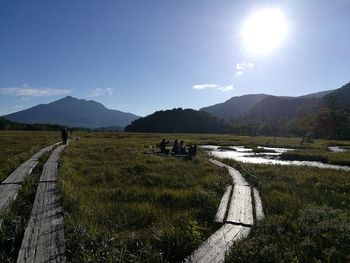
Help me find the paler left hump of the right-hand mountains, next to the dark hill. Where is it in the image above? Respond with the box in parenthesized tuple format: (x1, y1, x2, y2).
(200, 94, 269, 121)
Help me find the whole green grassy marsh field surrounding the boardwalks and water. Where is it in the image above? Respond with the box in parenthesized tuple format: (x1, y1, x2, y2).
(0, 132, 350, 262)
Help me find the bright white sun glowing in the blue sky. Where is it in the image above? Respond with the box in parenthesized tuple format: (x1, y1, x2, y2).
(242, 9, 287, 55)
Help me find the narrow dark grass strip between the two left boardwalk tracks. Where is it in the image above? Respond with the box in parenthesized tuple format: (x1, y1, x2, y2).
(0, 154, 48, 262)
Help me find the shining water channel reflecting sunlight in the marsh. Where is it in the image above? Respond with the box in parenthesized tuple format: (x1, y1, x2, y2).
(201, 145, 350, 171)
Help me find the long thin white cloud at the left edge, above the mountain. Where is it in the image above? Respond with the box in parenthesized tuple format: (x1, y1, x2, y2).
(0, 85, 72, 97)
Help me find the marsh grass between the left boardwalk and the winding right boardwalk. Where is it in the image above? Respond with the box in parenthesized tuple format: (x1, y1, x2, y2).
(60, 133, 230, 262)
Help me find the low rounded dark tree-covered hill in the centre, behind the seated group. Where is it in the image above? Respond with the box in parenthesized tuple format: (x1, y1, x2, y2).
(125, 108, 228, 133)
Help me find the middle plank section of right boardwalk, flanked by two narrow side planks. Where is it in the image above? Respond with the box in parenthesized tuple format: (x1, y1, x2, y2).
(226, 185, 254, 225)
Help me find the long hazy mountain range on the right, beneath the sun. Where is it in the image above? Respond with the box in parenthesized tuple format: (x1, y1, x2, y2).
(200, 90, 335, 121)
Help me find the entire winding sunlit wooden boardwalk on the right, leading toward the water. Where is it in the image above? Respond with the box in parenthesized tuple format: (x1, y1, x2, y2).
(186, 159, 264, 263)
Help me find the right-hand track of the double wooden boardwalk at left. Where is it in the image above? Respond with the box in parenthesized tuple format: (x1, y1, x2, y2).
(17, 145, 66, 263)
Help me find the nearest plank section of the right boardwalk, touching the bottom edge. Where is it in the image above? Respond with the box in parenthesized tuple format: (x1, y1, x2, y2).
(186, 224, 250, 263)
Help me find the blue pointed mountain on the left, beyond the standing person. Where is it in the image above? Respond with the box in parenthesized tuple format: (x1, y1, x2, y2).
(3, 96, 139, 129)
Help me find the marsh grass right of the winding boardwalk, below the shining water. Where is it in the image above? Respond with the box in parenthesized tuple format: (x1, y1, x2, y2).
(225, 160, 350, 262)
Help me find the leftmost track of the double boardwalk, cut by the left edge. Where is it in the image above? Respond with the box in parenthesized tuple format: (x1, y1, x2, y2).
(0, 143, 60, 216)
